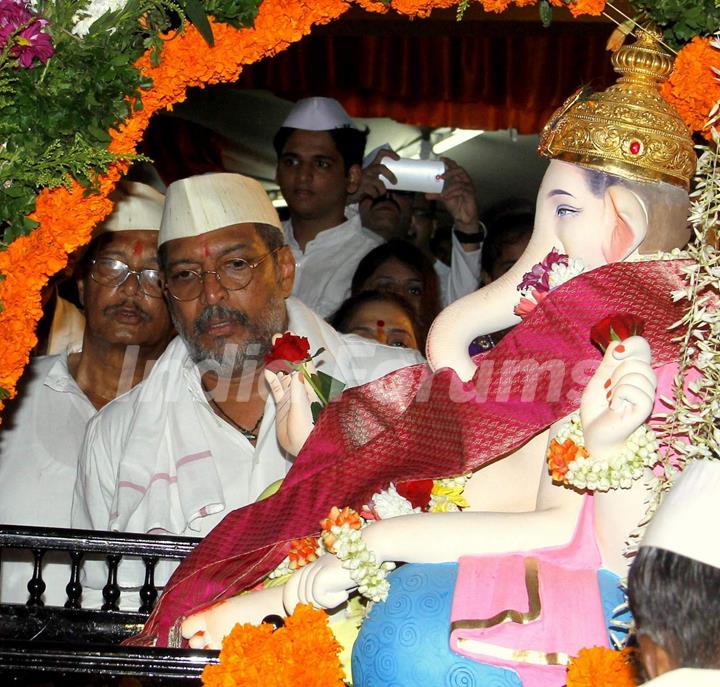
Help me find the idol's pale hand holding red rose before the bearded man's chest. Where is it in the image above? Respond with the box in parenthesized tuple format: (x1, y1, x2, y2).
(265, 363, 318, 456)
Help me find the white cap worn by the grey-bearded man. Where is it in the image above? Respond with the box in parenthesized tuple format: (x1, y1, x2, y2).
(158, 173, 282, 245)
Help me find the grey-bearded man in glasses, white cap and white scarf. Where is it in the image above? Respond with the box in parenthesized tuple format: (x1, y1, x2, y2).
(73, 173, 419, 552)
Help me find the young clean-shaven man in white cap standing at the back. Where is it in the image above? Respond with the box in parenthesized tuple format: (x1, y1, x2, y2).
(273, 98, 383, 317)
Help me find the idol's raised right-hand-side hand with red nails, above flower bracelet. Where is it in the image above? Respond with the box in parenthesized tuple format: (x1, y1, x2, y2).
(580, 336, 657, 458)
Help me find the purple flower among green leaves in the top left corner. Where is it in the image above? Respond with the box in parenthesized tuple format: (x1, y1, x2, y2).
(0, 0, 55, 68)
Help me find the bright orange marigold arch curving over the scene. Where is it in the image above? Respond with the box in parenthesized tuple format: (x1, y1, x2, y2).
(0, 0, 716, 410)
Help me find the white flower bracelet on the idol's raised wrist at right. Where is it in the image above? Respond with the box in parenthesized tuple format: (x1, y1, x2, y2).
(555, 411, 660, 491)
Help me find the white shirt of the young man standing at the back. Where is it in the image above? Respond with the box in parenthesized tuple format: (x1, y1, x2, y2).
(284, 215, 383, 317)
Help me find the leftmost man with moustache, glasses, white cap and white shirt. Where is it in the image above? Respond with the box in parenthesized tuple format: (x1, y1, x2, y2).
(0, 182, 173, 605)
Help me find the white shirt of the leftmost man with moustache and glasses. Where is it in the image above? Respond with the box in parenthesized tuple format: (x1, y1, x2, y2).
(0, 353, 95, 605)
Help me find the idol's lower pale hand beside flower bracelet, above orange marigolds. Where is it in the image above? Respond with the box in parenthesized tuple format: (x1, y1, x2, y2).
(283, 553, 356, 614)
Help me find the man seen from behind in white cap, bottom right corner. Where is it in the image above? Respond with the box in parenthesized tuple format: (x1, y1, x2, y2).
(628, 459, 720, 687)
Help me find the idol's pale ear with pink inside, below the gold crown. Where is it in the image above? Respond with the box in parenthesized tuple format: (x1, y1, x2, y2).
(602, 185, 649, 263)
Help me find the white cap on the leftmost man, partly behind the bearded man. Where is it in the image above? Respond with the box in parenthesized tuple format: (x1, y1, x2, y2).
(94, 181, 165, 236)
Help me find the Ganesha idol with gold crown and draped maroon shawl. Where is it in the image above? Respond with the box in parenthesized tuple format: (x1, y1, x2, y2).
(134, 32, 695, 687)
